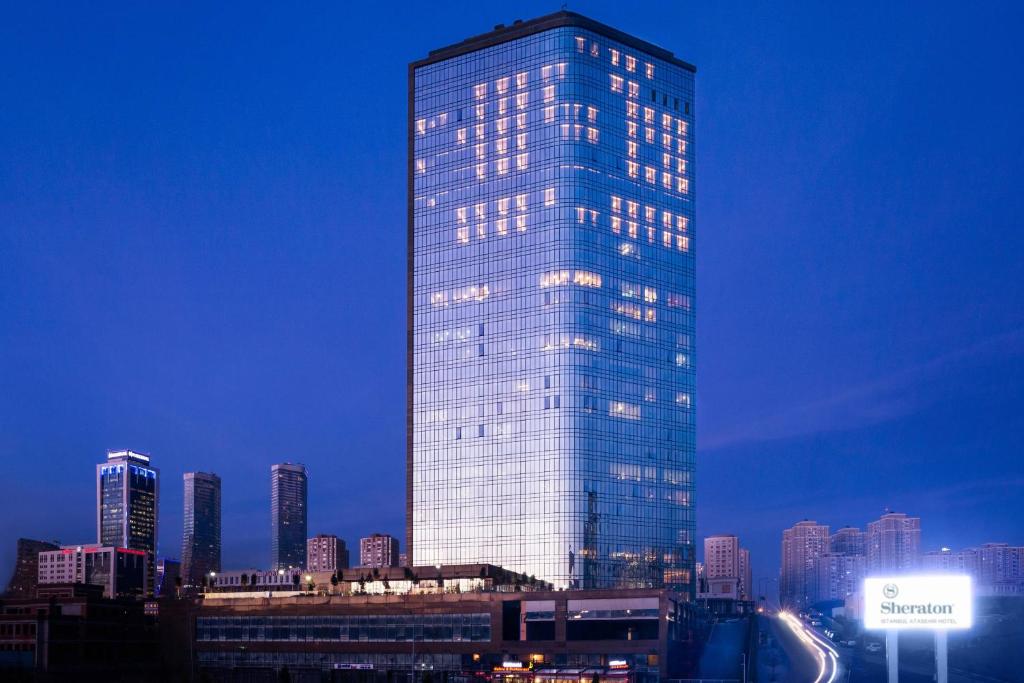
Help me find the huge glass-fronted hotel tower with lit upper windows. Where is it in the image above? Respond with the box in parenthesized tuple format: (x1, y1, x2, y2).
(407, 11, 695, 595)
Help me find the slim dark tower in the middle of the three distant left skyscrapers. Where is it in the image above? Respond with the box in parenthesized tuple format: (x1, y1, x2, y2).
(181, 472, 220, 586)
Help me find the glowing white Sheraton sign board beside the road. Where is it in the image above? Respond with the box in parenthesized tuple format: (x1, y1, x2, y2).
(864, 574, 974, 631)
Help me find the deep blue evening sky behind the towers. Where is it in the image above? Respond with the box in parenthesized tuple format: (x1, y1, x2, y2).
(0, 2, 1024, 582)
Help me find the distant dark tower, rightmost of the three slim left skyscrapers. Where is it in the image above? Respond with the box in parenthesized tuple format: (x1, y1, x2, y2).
(270, 463, 306, 569)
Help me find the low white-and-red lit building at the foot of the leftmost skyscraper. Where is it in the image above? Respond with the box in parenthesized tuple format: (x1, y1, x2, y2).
(39, 544, 154, 598)
